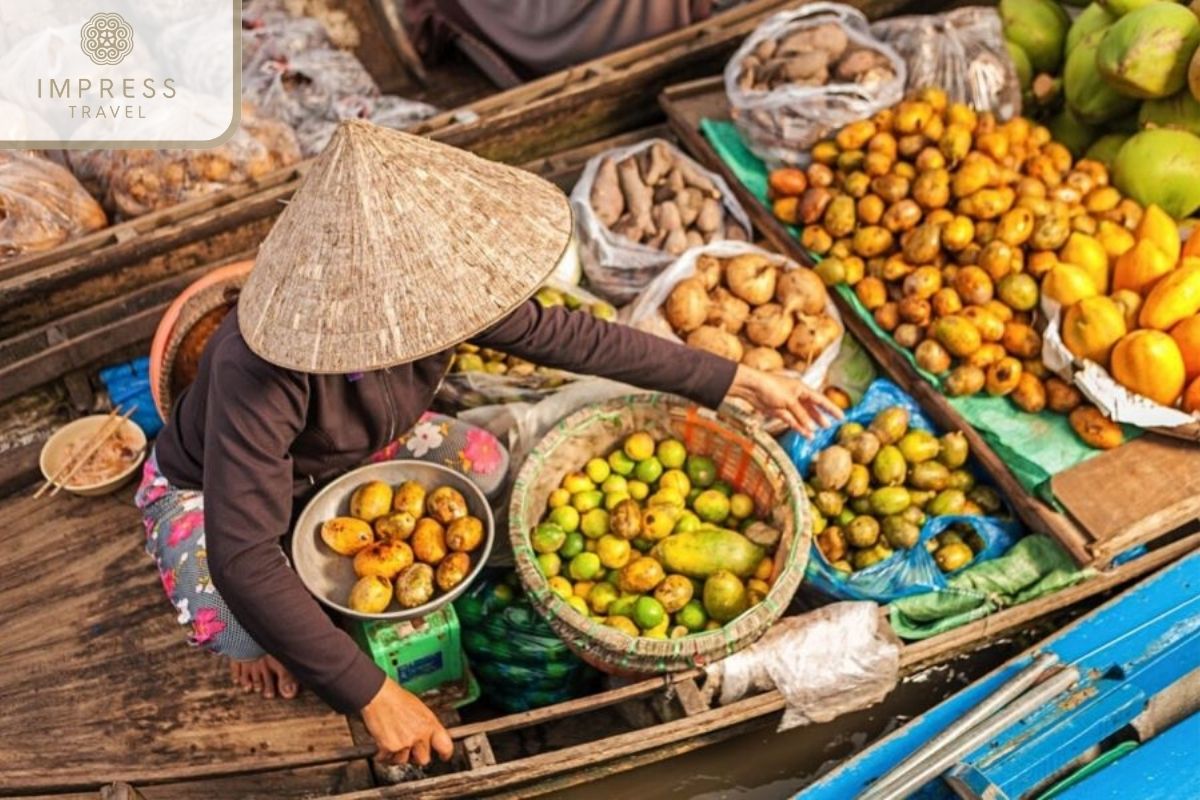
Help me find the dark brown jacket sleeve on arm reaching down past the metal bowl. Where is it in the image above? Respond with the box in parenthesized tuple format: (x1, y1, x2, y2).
(204, 343, 384, 714)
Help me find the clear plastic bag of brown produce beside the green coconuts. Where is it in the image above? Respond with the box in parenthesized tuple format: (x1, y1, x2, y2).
(871, 6, 1021, 120)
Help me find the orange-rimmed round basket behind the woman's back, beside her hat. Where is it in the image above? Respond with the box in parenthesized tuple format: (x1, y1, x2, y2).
(150, 261, 254, 420)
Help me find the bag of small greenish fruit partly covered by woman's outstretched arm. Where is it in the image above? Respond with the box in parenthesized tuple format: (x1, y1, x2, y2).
(438, 278, 617, 410)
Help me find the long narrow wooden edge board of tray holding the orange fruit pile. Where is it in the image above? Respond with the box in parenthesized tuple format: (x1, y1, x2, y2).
(661, 78, 1113, 564)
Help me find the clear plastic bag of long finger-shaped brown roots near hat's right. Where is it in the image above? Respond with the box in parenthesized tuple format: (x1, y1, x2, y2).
(571, 139, 750, 306)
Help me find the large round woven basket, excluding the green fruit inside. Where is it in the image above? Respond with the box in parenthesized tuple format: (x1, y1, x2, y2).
(509, 395, 812, 675)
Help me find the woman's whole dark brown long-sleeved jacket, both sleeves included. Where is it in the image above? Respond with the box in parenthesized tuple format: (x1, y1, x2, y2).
(156, 300, 737, 712)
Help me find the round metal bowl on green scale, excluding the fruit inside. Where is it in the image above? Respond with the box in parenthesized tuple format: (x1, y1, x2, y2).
(292, 461, 496, 620)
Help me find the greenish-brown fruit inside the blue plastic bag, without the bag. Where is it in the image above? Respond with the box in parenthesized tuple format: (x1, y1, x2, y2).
(805, 405, 1003, 572)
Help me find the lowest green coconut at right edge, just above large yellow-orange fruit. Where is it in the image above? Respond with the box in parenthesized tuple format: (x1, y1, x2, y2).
(1112, 128, 1200, 219)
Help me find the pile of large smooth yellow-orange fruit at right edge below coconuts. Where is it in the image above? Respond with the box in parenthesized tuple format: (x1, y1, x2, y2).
(1060, 205, 1200, 424)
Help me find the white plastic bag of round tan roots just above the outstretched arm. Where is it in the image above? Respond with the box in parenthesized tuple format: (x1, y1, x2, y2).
(622, 241, 844, 389)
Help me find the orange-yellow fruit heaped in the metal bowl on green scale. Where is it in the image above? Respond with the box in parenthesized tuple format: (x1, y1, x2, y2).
(320, 481, 486, 614)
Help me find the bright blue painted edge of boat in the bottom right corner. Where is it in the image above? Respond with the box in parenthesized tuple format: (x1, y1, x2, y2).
(796, 553, 1200, 800)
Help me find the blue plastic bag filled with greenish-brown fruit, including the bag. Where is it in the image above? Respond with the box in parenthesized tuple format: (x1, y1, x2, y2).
(781, 379, 1021, 603)
